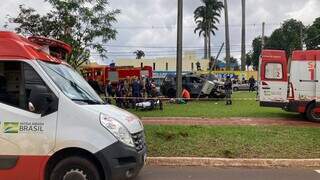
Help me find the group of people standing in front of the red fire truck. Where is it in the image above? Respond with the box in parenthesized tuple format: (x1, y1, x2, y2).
(105, 77, 159, 108)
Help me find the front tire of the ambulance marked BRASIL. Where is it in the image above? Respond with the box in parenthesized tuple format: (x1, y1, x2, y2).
(49, 156, 102, 180)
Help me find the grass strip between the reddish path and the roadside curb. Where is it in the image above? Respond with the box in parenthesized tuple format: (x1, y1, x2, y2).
(145, 126, 320, 159)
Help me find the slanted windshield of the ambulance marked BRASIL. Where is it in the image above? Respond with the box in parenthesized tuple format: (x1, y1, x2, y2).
(38, 61, 103, 104)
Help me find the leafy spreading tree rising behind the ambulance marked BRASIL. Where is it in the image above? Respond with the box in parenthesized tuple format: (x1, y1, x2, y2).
(9, 0, 120, 68)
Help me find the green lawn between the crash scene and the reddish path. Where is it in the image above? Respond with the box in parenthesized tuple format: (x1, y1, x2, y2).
(130, 92, 300, 118)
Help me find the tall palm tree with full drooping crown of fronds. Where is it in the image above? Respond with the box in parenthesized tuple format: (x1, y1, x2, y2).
(194, 0, 224, 59)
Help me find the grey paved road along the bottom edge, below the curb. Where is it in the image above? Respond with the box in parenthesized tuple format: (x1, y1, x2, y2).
(136, 167, 320, 180)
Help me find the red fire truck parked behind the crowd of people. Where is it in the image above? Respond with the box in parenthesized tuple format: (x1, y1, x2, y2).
(82, 64, 153, 86)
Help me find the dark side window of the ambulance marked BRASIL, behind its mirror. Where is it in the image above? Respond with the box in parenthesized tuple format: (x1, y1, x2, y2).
(0, 61, 58, 115)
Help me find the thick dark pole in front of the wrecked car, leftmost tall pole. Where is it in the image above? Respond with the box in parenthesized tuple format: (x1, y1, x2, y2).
(176, 0, 183, 98)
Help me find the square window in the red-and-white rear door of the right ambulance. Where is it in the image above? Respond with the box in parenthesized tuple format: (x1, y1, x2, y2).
(265, 63, 283, 80)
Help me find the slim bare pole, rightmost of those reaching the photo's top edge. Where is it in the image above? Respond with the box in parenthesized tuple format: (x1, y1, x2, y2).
(241, 0, 246, 71)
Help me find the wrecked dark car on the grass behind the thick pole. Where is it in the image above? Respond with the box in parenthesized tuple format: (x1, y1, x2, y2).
(160, 74, 225, 98)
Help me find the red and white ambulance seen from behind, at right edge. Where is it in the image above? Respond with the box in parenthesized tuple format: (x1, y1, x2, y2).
(259, 50, 320, 122)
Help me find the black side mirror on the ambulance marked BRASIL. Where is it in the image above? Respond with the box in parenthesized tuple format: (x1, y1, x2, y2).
(28, 85, 54, 116)
